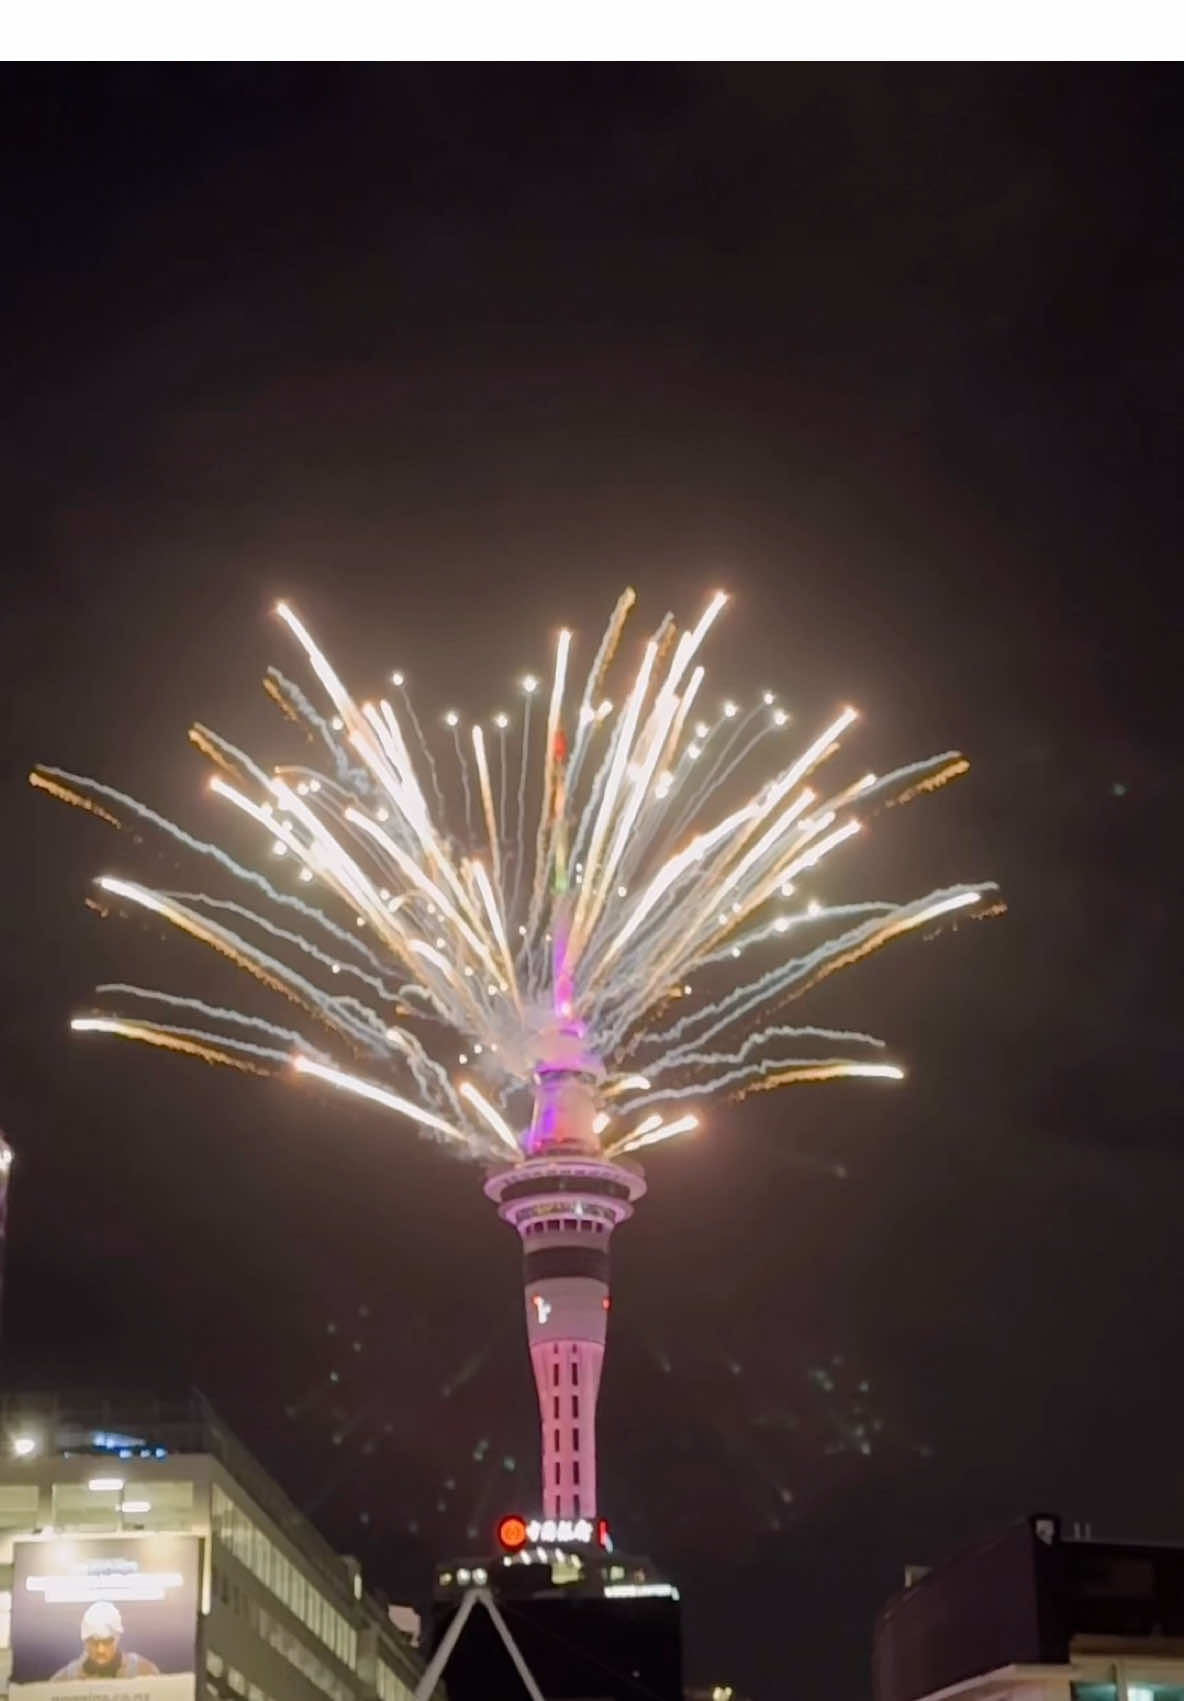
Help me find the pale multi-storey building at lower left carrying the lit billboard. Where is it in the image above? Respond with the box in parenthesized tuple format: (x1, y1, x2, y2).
(0, 1395, 439, 1701)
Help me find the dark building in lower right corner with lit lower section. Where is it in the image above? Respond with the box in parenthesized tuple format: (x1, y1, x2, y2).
(873, 1516, 1183, 1701)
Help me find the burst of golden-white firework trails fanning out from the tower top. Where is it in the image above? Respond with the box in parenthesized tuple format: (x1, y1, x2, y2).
(31, 592, 999, 1163)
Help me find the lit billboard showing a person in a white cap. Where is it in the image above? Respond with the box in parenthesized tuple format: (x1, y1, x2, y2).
(10, 1534, 201, 1701)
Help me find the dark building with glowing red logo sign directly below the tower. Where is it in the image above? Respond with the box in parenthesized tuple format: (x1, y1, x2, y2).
(432, 1516, 684, 1701)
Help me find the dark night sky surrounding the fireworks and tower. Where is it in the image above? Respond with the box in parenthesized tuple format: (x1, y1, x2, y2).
(0, 65, 1181, 1701)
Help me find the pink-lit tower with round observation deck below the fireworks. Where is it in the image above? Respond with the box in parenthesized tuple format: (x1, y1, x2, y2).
(485, 1068, 645, 1519)
